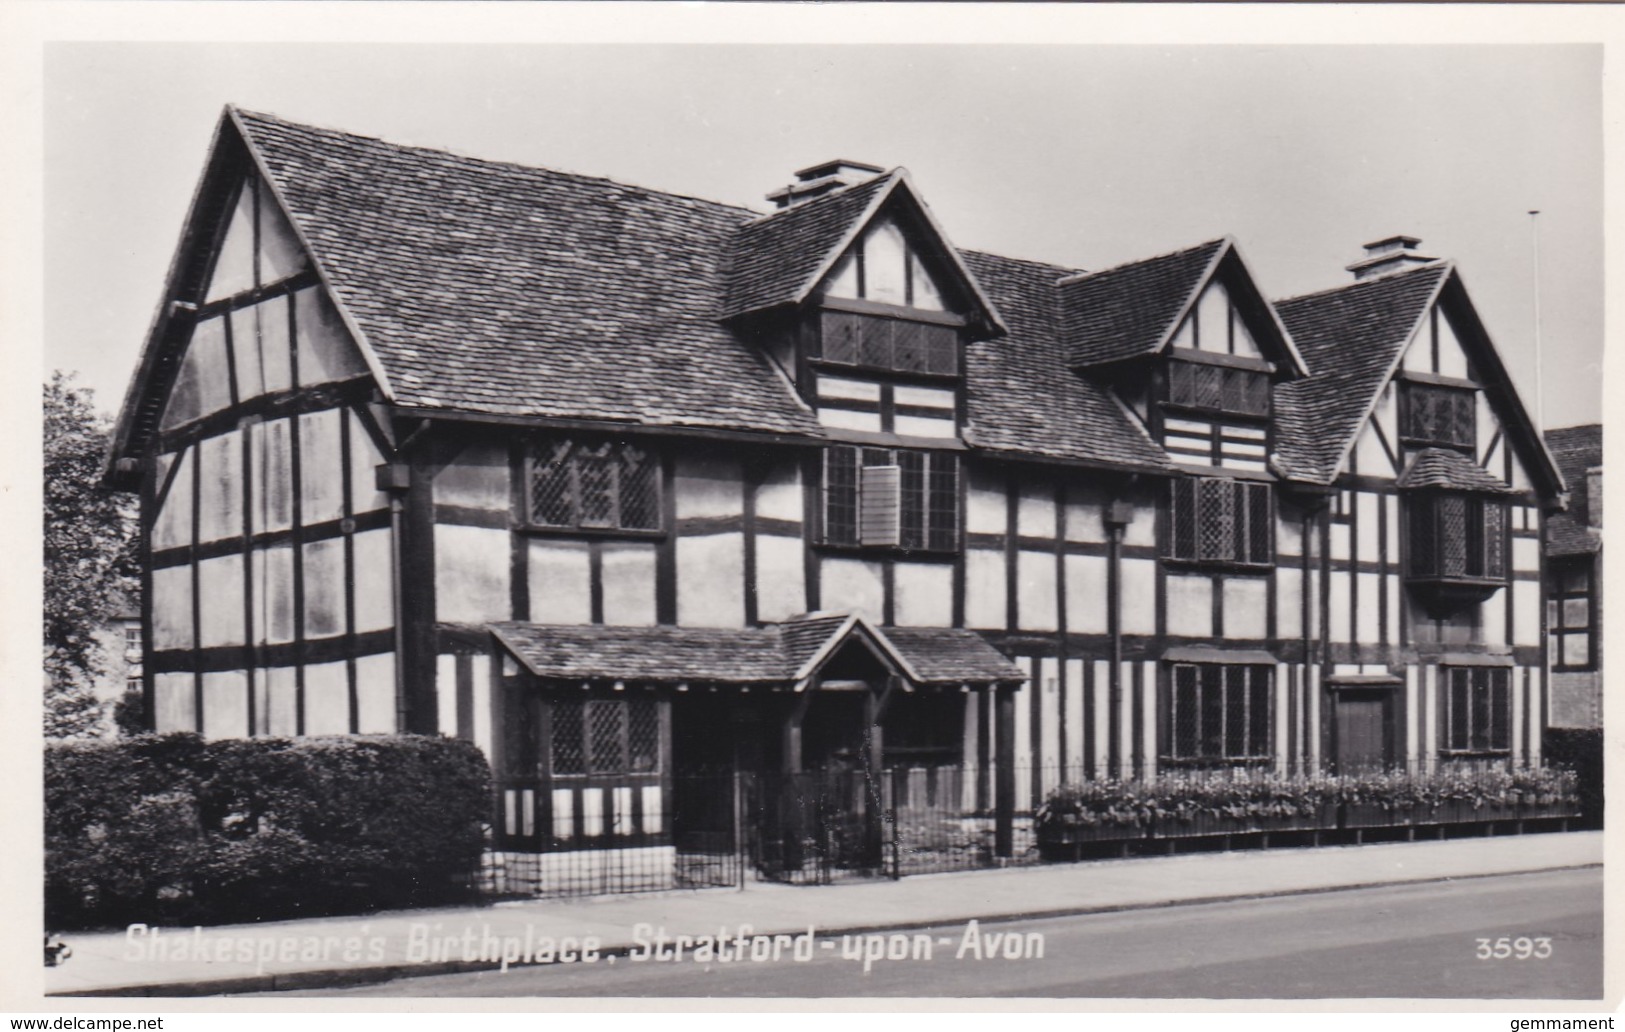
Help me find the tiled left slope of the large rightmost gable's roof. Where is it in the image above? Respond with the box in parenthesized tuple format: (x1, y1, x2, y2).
(1276, 263, 1450, 483)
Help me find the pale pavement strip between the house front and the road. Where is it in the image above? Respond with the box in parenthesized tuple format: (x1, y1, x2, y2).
(42, 832, 1602, 996)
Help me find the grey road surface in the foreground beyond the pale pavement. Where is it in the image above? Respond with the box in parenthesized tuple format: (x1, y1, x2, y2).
(250, 868, 1602, 999)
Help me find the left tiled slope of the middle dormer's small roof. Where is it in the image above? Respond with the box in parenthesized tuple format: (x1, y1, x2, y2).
(1058, 241, 1225, 366)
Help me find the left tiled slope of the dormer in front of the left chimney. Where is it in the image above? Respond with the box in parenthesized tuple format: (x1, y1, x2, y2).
(723, 174, 895, 317)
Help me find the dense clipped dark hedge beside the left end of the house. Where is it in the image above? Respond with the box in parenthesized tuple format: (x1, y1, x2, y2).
(46, 735, 491, 928)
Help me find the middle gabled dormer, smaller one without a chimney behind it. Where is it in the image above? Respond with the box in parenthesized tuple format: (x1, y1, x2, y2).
(1060, 239, 1305, 473)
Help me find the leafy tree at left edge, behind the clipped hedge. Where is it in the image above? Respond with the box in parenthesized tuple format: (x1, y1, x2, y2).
(44, 371, 138, 738)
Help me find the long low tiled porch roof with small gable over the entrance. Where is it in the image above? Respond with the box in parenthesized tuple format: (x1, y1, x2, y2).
(491, 613, 1025, 684)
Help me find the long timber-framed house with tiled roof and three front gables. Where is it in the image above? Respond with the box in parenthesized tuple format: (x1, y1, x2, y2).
(109, 107, 1563, 850)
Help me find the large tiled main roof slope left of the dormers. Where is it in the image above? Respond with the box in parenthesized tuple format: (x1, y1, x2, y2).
(236, 112, 817, 434)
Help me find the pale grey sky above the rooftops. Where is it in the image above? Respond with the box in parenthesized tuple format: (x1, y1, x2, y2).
(42, 42, 1604, 426)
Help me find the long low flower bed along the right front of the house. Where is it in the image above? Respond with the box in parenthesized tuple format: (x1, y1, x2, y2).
(1034, 767, 1578, 856)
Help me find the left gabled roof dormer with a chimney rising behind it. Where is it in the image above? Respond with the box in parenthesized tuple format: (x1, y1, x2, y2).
(726, 161, 1004, 439)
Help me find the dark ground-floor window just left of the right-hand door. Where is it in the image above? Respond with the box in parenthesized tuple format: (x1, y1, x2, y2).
(1168, 663, 1274, 762)
